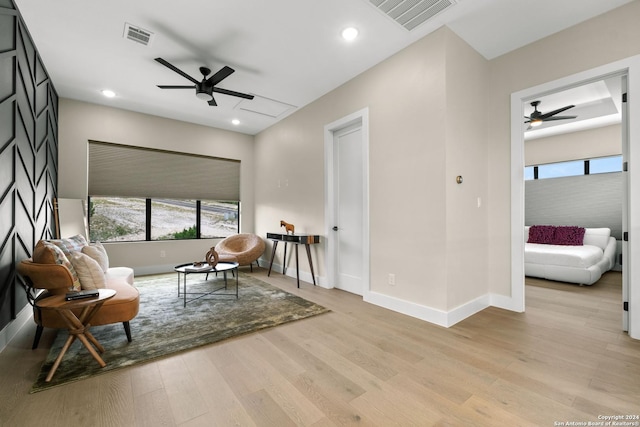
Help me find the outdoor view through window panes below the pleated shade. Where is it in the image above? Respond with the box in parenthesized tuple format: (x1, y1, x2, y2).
(89, 197, 239, 242)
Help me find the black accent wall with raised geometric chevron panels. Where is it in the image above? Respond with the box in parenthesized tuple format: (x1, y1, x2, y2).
(0, 0, 58, 330)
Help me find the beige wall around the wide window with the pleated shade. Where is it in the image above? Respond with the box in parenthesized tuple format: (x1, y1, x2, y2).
(58, 99, 254, 274)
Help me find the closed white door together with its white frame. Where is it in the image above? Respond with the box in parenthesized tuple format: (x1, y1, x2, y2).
(325, 109, 369, 296)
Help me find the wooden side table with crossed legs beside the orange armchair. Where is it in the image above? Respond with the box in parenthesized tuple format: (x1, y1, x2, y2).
(36, 289, 116, 382)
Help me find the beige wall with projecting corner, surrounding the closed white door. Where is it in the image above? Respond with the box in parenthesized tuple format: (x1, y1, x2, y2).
(256, 28, 488, 311)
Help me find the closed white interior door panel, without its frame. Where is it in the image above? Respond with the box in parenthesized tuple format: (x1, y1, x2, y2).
(332, 123, 364, 295)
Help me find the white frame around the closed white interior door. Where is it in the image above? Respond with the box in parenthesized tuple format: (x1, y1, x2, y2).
(324, 107, 371, 300)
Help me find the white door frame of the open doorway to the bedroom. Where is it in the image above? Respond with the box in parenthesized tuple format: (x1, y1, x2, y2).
(510, 55, 640, 339)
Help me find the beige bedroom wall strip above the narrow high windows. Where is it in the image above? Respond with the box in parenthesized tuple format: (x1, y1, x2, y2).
(524, 124, 622, 166)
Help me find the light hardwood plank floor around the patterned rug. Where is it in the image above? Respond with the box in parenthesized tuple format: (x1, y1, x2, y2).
(0, 269, 640, 427)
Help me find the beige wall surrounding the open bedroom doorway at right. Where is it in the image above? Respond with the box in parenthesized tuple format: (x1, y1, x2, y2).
(487, 1, 640, 295)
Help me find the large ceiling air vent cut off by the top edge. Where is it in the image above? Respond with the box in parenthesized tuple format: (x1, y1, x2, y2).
(369, 0, 455, 31)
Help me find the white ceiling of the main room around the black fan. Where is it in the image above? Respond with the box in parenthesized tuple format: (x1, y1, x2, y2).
(15, 0, 632, 134)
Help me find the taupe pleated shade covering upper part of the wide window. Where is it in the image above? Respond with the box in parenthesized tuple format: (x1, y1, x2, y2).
(89, 141, 240, 201)
